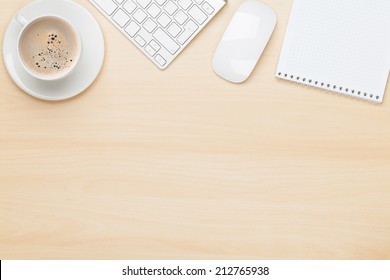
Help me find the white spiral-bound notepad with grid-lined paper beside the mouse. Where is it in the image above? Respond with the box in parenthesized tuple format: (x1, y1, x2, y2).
(276, 0, 390, 102)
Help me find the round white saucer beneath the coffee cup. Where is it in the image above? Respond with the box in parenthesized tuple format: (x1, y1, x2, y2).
(3, 0, 104, 101)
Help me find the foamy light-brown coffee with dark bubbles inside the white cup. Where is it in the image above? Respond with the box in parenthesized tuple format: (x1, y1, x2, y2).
(19, 16, 80, 79)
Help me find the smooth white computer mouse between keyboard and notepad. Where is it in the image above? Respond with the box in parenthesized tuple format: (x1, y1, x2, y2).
(213, 0, 276, 83)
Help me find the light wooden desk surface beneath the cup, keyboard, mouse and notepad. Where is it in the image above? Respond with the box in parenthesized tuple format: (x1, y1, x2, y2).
(0, 0, 390, 259)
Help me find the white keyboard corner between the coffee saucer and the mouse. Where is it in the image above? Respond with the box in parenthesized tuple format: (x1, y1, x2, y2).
(90, 0, 227, 69)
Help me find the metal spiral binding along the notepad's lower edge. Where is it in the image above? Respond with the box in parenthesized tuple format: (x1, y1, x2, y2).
(277, 72, 380, 100)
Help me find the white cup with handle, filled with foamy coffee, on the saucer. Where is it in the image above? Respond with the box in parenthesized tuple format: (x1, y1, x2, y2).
(15, 14, 82, 81)
